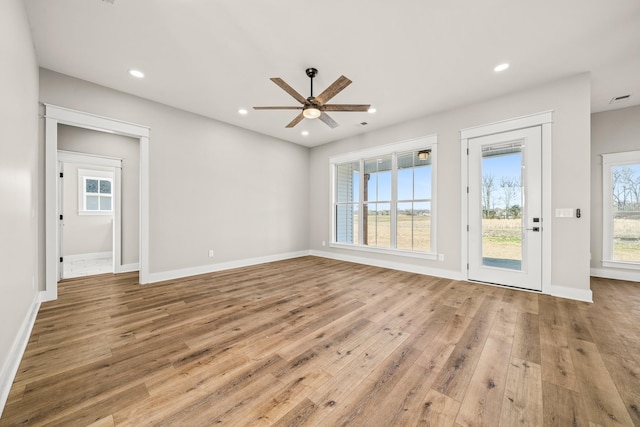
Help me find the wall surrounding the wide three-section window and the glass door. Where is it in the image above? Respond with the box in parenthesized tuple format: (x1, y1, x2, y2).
(309, 74, 591, 293)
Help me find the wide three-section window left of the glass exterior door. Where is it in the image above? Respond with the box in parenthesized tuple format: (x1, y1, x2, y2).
(331, 136, 436, 255)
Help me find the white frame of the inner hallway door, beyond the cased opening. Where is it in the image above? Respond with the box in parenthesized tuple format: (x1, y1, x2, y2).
(57, 150, 124, 278)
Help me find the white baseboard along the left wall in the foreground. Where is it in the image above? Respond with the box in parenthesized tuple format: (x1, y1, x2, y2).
(0, 293, 41, 417)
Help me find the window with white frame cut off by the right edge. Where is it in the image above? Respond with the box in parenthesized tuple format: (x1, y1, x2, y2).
(602, 151, 640, 269)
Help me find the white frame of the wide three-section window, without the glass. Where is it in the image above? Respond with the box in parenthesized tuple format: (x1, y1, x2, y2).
(329, 135, 438, 260)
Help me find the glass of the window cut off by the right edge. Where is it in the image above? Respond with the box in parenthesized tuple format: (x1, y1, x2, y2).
(611, 164, 640, 262)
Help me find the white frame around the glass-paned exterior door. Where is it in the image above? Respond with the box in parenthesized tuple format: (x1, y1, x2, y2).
(460, 111, 553, 294)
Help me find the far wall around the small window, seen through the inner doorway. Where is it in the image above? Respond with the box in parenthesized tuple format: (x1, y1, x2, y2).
(60, 163, 113, 257)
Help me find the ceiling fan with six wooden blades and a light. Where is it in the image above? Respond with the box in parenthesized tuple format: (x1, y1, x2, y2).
(253, 68, 369, 129)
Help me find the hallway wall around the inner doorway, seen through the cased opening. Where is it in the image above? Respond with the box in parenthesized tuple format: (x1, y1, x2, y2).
(58, 125, 140, 264)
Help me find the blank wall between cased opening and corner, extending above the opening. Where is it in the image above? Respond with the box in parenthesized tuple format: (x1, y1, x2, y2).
(40, 69, 309, 277)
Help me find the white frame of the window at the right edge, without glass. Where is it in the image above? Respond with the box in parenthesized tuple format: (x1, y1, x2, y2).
(602, 151, 640, 270)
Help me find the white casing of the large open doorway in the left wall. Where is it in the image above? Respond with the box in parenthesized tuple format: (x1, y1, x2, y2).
(41, 104, 149, 301)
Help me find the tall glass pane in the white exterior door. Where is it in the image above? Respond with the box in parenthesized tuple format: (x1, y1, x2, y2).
(482, 144, 523, 270)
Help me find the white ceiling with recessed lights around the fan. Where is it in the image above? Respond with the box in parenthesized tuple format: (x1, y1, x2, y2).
(25, 0, 640, 147)
